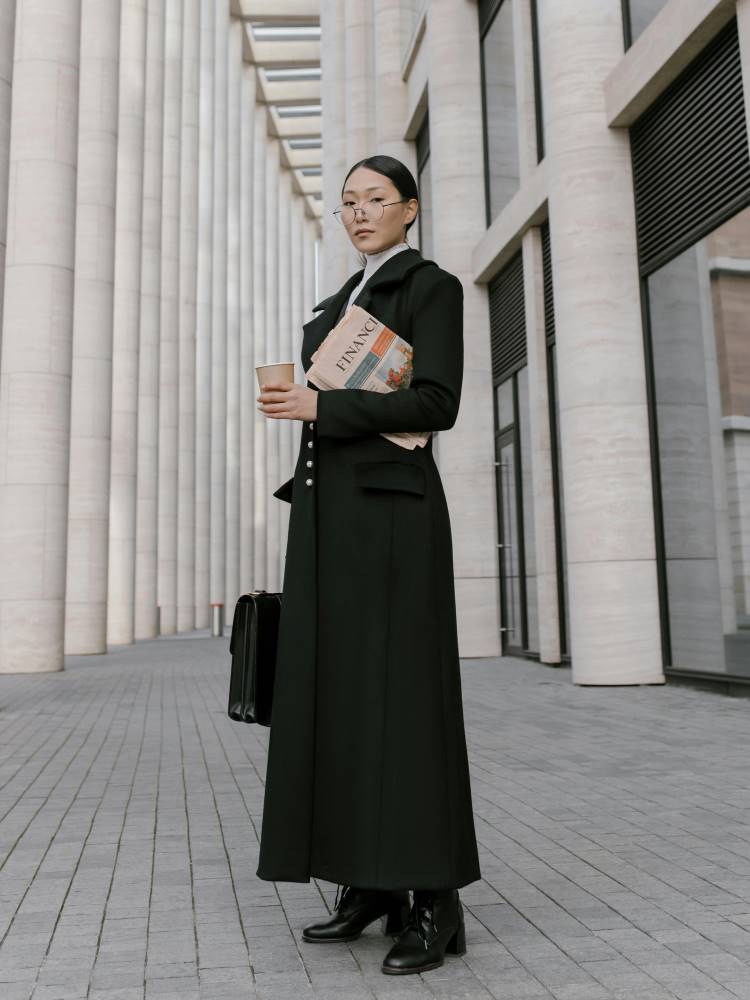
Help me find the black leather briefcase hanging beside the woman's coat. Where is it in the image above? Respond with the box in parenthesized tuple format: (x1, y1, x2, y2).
(228, 590, 281, 726)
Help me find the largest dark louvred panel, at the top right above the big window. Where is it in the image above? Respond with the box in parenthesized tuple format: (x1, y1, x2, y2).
(630, 18, 750, 275)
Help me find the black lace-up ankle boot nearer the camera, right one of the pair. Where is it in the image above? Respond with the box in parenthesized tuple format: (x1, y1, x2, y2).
(382, 889, 466, 975)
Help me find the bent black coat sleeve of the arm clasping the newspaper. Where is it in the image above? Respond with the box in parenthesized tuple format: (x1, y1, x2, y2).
(317, 274, 464, 438)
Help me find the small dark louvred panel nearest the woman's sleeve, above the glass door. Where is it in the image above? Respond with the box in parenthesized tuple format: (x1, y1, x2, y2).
(488, 250, 526, 385)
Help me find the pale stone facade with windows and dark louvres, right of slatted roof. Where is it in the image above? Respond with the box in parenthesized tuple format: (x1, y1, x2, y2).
(321, 0, 750, 685)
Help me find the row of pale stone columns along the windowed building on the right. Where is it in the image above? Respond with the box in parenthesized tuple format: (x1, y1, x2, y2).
(321, 0, 663, 684)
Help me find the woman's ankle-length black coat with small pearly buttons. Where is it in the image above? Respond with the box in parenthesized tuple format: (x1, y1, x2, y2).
(257, 249, 481, 889)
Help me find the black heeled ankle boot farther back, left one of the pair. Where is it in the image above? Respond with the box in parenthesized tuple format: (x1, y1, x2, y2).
(302, 885, 409, 942)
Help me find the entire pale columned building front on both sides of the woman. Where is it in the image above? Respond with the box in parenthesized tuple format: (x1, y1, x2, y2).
(0, 0, 750, 690)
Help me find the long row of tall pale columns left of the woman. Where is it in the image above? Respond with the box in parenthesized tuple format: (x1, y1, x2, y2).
(0, 0, 318, 672)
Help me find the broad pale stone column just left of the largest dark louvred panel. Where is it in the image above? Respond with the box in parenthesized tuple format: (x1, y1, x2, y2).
(539, 0, 664, 684)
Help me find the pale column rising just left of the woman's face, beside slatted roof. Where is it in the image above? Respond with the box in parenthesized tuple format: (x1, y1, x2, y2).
(318, 0, 358, 292)
